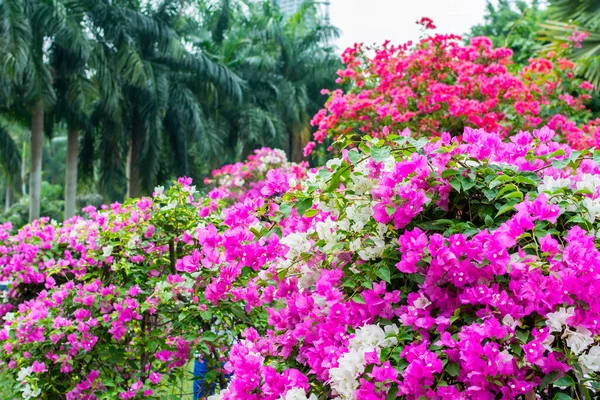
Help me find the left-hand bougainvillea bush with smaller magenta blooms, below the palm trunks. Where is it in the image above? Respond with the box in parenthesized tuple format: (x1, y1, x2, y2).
(0, 149, 304, 399)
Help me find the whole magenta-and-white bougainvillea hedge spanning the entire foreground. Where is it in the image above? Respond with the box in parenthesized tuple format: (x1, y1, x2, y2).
(0, 128, 600, 400)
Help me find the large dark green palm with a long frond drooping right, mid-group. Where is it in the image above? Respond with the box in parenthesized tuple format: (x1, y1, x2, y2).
(84, 0, 242, 197)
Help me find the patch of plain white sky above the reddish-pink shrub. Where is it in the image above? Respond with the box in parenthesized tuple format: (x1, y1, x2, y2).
(329, 0, 486, 49)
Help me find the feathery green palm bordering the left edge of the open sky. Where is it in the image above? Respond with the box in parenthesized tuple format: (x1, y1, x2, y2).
(193, 0, 340, 161)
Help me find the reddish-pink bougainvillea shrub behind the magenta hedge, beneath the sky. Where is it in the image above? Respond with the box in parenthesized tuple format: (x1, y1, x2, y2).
(308, 31, 600, 150)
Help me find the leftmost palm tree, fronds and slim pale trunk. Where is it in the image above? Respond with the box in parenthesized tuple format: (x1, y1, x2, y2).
(0, 0, 87, 221)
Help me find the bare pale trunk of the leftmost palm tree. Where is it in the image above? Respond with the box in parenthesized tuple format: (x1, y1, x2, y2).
(29, 101, 44, 222)
